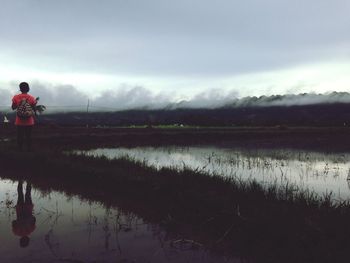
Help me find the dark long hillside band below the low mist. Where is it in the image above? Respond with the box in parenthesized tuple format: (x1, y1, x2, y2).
(7, 103, 350, 127)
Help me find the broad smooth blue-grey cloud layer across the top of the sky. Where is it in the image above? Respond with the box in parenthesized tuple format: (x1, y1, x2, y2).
(0, 0, 350, 76)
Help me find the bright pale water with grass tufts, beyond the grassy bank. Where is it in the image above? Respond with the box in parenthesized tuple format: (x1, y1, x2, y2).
(85, 146, 350, 201)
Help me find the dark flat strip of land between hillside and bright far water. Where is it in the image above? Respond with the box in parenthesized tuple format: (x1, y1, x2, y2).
(0, 125, 350, 152)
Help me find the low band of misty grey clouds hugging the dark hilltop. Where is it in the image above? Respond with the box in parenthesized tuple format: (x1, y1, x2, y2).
(0, 82, 350, 113)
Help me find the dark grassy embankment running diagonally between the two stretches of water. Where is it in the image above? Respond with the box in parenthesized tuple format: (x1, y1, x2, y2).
(0, 127, 350, 262)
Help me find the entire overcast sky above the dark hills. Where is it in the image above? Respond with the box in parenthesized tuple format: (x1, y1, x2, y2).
(0, 0, 350, 108)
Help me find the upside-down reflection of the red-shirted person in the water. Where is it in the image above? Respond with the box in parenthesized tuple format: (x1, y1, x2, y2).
(12, 180, 36, 247)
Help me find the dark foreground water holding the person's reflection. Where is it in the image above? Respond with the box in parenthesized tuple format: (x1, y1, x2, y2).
(0, 180, 239, 263)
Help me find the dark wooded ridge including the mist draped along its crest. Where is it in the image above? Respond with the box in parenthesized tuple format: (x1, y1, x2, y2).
(2, 92, 350, 127)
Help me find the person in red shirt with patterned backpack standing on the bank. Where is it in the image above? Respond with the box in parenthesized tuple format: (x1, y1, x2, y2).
(12, 82, 37, 151)
